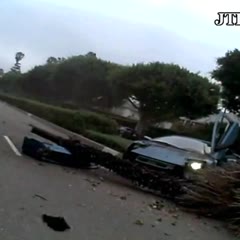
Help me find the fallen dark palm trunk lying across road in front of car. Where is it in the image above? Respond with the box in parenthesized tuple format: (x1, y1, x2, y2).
(27, 127, 188, 199)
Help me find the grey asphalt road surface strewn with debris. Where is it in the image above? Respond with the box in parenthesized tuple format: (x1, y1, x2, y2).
(0, 102, 236, 240)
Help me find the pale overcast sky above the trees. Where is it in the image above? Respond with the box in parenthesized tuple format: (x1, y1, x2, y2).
(0, 0, 240, 75)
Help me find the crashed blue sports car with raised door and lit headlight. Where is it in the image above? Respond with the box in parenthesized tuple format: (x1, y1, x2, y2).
(123, 112, 239, 176)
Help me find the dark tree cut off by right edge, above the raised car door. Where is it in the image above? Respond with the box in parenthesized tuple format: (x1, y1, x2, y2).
(212, 49, 240, 114)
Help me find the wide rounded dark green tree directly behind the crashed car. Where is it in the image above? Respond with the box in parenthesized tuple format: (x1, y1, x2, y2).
(110, 62, 219, 135)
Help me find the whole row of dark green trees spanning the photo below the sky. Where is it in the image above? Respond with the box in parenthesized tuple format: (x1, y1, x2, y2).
(0, 49, 240, 136)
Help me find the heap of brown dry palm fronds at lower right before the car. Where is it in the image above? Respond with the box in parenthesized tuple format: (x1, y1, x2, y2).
(178, 163, 240, 234)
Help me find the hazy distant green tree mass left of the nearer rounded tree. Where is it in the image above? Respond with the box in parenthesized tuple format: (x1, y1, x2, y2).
(15, 52, 122, 108)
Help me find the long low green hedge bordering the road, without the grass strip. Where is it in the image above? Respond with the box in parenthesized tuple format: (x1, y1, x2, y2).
(0, 95, 118, 134)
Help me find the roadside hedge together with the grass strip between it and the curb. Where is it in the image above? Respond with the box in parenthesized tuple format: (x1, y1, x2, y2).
(0, 95, 131, 152)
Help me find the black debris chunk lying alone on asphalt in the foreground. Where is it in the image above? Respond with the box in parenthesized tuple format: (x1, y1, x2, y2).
(42, 214, 70, 232)
